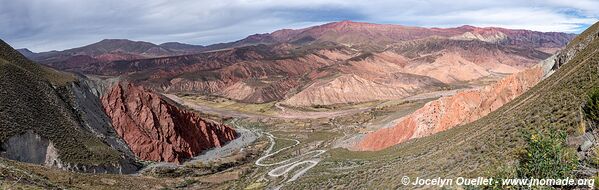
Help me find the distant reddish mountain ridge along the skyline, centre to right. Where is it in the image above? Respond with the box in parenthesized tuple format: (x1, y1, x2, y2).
(226, 21, 575, 49)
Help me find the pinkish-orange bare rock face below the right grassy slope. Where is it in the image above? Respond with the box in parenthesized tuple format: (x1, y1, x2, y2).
(356, 66, 543, 151)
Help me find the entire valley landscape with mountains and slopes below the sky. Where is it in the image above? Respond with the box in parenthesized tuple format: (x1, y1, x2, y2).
(0, 17, 599, 189)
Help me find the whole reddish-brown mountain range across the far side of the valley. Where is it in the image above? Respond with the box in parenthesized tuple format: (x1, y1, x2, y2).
(27, 21, 574, 106)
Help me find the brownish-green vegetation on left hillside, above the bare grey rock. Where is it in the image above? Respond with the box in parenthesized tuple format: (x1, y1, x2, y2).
(0, 41, 121, 165)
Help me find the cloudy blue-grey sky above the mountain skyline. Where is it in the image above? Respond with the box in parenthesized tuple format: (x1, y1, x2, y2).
(0, 0, 599, 51)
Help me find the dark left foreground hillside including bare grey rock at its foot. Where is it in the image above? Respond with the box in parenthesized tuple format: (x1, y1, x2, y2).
(0, 41, 137, 173)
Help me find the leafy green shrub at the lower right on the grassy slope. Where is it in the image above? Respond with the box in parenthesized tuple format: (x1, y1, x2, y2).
(516, 130, 578, 179)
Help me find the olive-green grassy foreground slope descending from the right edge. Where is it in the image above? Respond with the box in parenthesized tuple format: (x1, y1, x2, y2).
(293, 21, 599, 188)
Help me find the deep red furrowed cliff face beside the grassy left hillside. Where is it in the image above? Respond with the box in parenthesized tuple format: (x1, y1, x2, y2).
(102, 84, 236, 163)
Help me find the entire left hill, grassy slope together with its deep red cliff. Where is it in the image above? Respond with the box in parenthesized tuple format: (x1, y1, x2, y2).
(0, 41, 237, 173)
